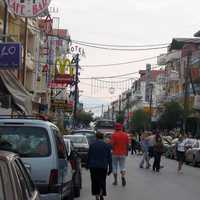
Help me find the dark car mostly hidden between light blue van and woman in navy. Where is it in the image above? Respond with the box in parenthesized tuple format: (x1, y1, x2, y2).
(64, 138, 82, 197)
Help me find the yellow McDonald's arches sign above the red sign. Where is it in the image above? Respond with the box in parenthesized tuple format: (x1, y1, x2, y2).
(56, 58, 76, 76)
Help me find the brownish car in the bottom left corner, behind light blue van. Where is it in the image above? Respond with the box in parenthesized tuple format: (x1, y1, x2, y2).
(0, 151, 40, 200)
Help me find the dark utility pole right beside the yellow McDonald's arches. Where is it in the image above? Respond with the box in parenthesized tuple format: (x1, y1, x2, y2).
(73, 54, 79, 127)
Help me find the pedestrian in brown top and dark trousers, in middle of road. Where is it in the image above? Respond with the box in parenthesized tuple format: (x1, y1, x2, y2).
(153, 134, 164, 172)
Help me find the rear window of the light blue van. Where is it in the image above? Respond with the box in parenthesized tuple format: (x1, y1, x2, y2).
(0, 126, 51, 157)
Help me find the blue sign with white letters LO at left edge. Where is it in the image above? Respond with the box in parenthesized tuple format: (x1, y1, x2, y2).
(0, 43, 21, 70)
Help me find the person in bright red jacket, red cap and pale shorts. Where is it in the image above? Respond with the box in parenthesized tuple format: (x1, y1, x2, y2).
(111, 123, 129, 186)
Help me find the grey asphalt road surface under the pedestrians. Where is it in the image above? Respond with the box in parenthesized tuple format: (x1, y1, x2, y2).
(77, 156, 200, 200)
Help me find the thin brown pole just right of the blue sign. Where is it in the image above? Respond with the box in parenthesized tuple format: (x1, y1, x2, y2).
(22, 17, 28, 86)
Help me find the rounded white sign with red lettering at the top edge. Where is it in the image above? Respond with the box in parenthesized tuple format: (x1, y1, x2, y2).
(6, 0, 51, 17)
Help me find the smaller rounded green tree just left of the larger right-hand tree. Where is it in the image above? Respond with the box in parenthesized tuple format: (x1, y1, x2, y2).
(130, 109, 150, 131)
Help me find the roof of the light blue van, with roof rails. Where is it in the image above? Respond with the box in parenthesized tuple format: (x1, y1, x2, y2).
(0, 119, 56, 127)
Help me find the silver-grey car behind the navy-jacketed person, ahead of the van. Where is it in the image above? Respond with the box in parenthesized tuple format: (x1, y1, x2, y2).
(64, 135, 89, 164)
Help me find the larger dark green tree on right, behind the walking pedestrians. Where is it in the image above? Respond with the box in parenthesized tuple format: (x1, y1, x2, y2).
(158, 101, 184, 130)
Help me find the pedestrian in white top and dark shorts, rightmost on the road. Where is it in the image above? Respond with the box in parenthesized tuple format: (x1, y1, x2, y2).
(176, 135, 186, 173)
